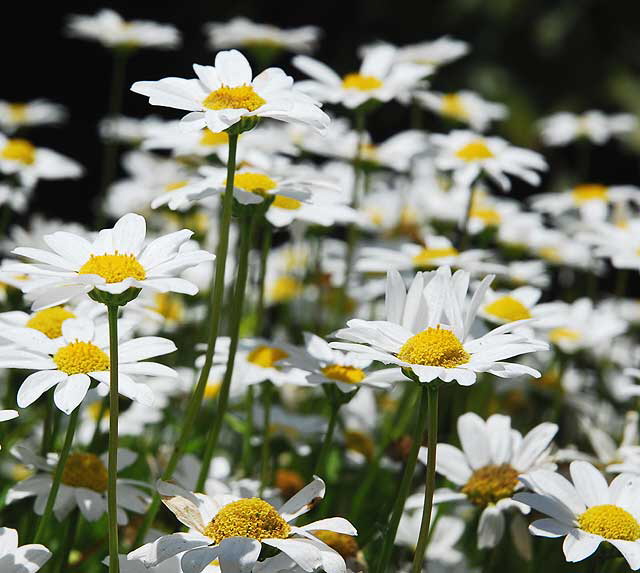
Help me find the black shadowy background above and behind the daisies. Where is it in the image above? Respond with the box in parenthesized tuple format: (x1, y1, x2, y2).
(0, 0, 640, 226)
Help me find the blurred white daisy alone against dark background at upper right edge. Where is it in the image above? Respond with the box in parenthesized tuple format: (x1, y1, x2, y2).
(539, 110, 638, 146)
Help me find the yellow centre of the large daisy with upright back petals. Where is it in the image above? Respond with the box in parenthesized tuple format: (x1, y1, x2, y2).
(398, 325, 471, 368)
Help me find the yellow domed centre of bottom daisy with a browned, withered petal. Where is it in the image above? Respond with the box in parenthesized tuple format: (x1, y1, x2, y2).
(204, 497, 291, 544)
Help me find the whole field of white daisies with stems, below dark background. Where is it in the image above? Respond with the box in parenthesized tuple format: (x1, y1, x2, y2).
(0, 9, 640, 573)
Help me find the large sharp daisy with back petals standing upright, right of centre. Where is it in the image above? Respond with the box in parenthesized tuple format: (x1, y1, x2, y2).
(331, 267, 548, 386)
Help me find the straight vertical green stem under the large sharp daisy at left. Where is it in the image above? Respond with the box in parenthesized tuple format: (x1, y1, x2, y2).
(107, 304, 120, 573)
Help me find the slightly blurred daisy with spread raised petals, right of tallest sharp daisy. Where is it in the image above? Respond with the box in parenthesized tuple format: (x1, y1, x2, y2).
(293, 44, 432, 109)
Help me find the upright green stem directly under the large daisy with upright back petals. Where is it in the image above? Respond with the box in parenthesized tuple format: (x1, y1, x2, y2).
(411, 382, 438, 573)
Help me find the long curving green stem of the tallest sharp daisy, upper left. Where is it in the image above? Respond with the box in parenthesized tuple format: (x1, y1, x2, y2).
(132, 131, 238, 547)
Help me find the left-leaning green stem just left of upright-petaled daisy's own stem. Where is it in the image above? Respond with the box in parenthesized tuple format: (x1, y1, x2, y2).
(376, 384, 429, 573)
